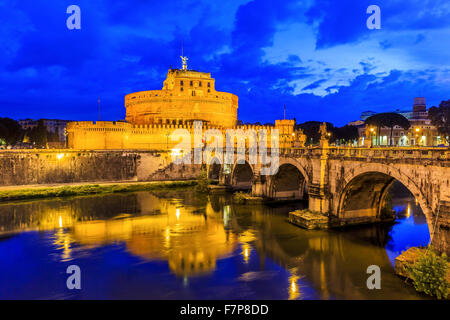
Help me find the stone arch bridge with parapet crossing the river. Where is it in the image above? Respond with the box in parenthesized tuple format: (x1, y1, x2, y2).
(215, 147, 450, 253)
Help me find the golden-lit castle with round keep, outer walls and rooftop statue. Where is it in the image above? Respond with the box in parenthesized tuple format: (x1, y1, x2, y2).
(67, 57, 296, 150)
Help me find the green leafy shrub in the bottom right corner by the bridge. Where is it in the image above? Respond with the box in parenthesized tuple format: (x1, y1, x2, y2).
(408, 249, 450, 299)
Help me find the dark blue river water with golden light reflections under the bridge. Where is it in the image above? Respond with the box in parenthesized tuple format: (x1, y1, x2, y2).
(0, 190, 429, 299)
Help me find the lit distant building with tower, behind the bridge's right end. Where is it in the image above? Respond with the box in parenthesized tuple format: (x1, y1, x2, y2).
(358, 97, 444, 146)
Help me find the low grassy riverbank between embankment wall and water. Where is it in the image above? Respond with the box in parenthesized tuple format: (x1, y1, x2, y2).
(0, 180, 197, 202)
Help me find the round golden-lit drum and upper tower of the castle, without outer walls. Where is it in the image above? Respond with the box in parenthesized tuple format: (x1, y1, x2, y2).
(125, 66, 238, 128)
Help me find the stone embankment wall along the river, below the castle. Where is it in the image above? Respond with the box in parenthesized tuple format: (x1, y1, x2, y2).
(0, 150, 201, 186)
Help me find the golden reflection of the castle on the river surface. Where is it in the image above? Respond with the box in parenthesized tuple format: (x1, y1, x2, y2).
(42, 193, 237, 276)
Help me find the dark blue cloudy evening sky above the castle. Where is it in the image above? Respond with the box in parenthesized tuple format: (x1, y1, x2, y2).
(0, 0, 450, 125)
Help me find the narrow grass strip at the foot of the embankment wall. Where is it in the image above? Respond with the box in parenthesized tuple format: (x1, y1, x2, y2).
(0, 181, 197, 202)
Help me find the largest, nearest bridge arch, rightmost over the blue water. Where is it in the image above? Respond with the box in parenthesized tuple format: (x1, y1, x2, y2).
(332, 163, 432, 232)
